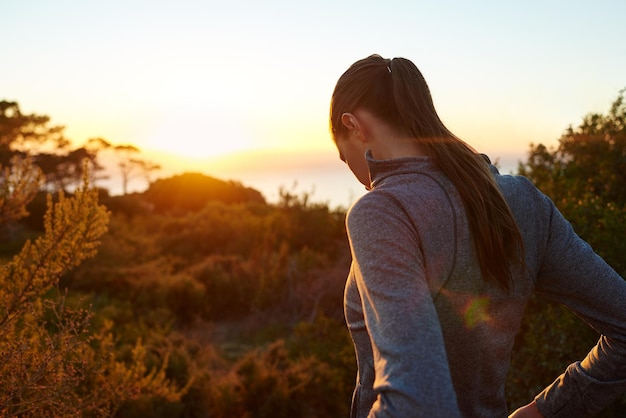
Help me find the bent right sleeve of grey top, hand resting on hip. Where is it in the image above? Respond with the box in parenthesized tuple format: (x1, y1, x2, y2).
(536, 190, 626, 418)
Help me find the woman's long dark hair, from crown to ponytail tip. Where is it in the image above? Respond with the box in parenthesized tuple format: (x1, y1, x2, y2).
(330, 55, 524, 289)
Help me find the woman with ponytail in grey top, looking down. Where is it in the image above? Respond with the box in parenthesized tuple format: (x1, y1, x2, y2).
(330, 55, 626, 418)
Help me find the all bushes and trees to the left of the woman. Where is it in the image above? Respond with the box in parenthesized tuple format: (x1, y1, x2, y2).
(0, 99, 354, 417)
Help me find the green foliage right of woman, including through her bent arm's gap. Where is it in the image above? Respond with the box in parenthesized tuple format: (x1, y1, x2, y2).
(507, 90, 626, 417)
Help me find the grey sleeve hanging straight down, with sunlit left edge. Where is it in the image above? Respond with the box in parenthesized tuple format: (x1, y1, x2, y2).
(347, 195, 460, 418)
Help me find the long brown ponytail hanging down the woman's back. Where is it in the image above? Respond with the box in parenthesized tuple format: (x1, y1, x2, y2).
(389, 58, 524, 288)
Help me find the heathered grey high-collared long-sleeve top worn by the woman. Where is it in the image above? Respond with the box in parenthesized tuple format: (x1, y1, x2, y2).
(344, 153, 626, 418)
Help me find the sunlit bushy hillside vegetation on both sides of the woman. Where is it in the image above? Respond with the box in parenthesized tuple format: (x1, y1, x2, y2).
(0, 90, 626, 418)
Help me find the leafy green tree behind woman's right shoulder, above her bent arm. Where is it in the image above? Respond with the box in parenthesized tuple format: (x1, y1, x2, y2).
(519, 89, 626, 275)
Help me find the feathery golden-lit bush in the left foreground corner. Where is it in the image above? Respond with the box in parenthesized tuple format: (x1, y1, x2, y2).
(0, 162, 190, 417)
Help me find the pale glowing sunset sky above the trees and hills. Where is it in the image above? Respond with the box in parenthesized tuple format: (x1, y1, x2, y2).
(0, 0, 626, 207)
